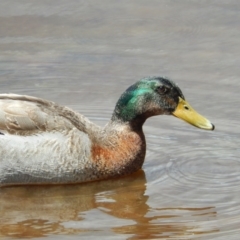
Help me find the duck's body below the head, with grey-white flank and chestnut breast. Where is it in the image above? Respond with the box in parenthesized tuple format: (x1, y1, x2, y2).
(0, 94, 146, 185)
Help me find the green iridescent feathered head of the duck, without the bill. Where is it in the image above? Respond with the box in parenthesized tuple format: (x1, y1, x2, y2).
(113, 77, 184, 122)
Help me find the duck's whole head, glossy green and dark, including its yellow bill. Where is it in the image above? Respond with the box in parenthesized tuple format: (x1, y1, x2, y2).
(112, 77, 214, 130)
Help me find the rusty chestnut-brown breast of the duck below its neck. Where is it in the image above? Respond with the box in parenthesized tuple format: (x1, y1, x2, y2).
(91, 130, 146, 176)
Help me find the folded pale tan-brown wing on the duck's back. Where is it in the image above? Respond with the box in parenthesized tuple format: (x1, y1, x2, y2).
(0, 94, 97, 136)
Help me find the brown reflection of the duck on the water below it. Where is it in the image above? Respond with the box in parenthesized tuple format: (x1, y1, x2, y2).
(0, 170, 216, 239)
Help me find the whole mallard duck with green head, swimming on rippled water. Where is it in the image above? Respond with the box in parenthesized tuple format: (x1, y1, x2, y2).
(0, 77, 215, 187)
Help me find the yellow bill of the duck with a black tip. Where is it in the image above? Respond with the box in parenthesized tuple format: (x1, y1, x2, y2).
(172, 97, 215, 130)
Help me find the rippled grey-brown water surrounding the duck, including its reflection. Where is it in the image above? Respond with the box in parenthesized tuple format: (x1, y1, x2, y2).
(0, 0, 240, 240)
